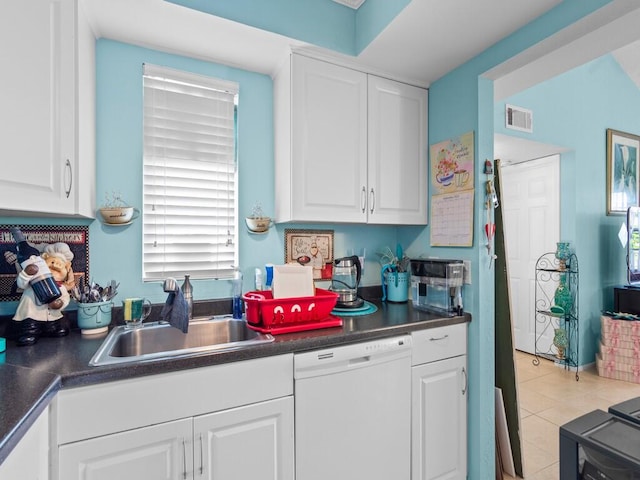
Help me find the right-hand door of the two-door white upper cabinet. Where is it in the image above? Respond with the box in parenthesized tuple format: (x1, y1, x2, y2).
(368, 75, 428, 225)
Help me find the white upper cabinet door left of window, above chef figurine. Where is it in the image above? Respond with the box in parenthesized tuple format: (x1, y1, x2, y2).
(0, 0, 75, 213)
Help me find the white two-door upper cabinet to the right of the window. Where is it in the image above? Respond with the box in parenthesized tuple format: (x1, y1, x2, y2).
(274, 54, 427, 224)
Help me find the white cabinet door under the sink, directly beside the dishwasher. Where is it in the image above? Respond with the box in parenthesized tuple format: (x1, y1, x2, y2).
(194, 397, 294, 480)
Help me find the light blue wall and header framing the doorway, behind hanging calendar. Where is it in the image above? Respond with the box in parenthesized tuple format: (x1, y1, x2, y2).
(423, 0, 608, 480)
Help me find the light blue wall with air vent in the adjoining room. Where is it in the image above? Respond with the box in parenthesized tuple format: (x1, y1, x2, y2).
(494, 55, 640, 364)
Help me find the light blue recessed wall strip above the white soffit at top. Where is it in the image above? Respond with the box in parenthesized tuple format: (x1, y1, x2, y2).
(167, 0, 409, 55)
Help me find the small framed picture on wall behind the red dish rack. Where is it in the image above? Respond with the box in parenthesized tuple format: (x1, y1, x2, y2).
(284, 228, 333, 280)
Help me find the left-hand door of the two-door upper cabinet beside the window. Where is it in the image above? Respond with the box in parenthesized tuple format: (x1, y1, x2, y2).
(290, 55, 367, 222)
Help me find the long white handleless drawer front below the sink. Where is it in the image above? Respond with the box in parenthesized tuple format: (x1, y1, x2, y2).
(55, 354, 293, 445)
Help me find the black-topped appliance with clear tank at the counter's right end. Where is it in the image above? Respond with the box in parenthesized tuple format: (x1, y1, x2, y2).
(411, 259, 464, 317)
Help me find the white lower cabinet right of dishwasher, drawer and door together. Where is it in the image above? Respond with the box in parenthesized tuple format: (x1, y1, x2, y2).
(411, 324, 467, 480)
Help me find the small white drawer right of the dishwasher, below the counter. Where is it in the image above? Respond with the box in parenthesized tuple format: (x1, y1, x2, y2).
(411, 323, 467, 365)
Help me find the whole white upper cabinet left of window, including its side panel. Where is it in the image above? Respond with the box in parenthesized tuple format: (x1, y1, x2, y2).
(0, 0, 95, 217)
